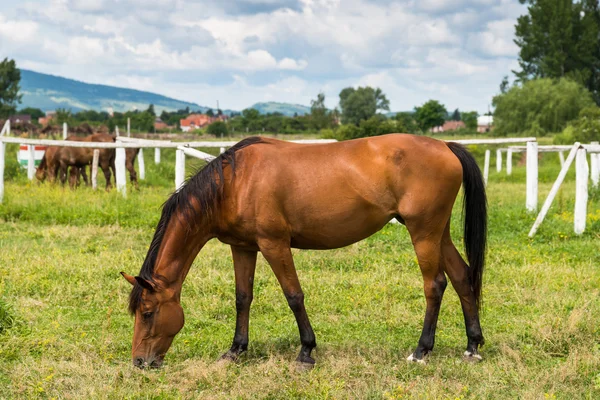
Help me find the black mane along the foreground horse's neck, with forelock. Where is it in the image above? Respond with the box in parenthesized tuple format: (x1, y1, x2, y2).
(129, 137, 262, 314)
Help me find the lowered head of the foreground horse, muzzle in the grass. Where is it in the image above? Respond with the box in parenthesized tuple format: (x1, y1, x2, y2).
(121, 272, 184, 368)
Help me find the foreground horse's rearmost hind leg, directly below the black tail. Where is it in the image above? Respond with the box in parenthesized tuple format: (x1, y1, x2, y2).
(442, 222, 484, 360)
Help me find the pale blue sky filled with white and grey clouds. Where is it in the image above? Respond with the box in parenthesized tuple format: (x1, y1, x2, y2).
(0, 0, 525, 112)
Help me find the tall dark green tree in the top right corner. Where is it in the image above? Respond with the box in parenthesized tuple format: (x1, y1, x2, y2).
(515, 0, 600, 101)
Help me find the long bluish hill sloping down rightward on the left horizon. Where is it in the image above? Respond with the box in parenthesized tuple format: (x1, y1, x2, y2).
(20, 69, 231, 114)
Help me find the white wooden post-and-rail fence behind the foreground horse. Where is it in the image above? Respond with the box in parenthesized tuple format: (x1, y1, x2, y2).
(0, 126, 600, 236)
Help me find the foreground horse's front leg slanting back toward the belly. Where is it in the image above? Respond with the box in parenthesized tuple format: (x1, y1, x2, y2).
(258, 239, 317, 368)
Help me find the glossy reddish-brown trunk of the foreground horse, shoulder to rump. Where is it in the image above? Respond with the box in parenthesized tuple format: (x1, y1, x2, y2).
(219, 134, 462, 248)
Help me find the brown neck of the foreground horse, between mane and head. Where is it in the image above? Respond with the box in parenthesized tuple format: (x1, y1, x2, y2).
(154, 216, 214, 287)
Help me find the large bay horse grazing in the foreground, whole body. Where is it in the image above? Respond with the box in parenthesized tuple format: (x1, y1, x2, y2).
(121, 134, 487, 368)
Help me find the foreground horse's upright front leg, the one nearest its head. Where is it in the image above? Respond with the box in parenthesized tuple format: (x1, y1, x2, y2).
(221, 246, 257, 361)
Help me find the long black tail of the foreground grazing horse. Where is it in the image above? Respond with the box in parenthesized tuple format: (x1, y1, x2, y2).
(448, 142, 487, 308)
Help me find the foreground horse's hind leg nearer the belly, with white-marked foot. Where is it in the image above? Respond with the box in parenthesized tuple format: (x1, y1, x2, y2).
(406, 221, 447, 363)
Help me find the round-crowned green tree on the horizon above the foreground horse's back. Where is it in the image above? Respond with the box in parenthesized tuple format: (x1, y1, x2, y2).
(340, 86, 390, 126)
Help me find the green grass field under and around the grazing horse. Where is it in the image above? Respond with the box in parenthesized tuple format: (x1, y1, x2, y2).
(0, 142, 600, 399)
